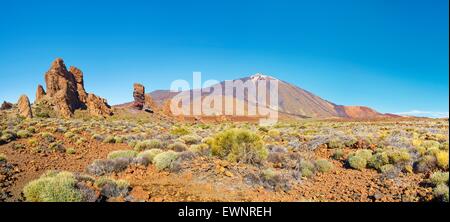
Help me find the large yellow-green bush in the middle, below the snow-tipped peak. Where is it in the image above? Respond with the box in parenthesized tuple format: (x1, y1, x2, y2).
(211, 129, 269, 163)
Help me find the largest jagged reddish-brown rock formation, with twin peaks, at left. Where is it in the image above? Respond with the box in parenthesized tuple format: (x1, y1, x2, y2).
(36, 58, 112, 118)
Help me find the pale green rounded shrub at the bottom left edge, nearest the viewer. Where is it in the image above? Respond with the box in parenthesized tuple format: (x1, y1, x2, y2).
(23, 171, 83, 202)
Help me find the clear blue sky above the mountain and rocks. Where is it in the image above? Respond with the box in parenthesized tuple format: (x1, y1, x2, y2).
(0, 0, 449, 115)
